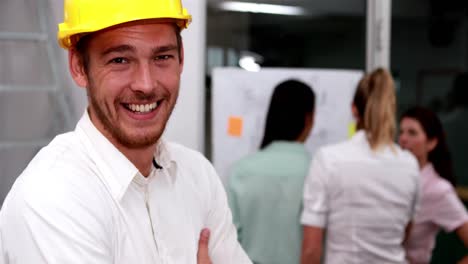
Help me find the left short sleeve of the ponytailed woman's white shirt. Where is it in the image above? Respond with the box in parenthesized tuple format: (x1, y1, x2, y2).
(301, 150, 330, 228)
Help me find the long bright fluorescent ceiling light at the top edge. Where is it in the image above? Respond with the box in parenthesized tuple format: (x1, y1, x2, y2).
(219, 1, 306, 16)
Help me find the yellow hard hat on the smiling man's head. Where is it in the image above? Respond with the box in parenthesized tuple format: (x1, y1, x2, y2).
(57, 0, 192, 49)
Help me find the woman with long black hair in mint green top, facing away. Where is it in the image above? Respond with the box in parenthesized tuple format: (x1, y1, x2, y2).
(227, 80, 315, 264)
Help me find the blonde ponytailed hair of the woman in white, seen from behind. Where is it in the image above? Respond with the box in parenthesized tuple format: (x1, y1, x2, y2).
(353, 68, 396, 150)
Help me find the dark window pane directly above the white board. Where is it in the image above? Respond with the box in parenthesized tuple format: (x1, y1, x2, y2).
(207, 0, 366, 69)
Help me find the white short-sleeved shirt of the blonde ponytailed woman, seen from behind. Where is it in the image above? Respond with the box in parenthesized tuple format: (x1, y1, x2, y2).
(301, 131, 419, 264)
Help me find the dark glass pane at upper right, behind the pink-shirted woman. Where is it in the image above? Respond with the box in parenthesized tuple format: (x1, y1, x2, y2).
(391, 0, 468, 185)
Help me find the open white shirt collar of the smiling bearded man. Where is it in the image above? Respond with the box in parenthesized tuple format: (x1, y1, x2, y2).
(75, 111, 174, 200)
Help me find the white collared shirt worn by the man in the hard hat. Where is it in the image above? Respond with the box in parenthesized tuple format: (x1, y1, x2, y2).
(0, 113, 251, 264)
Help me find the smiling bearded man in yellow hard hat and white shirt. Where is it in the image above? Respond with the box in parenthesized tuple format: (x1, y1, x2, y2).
(0, 0, 251, 264)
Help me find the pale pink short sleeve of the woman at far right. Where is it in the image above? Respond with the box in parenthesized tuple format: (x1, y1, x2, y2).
(432, 188, 468, 232)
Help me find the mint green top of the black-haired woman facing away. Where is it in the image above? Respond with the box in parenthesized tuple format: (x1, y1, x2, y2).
(227, 141, 310, 264)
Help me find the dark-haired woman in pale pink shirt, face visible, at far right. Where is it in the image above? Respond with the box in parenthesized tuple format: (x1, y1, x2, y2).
(399, 107, 468, 264)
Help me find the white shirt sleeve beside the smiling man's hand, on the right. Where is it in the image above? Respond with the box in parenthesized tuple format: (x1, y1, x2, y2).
(206, 164, 252, 264)
